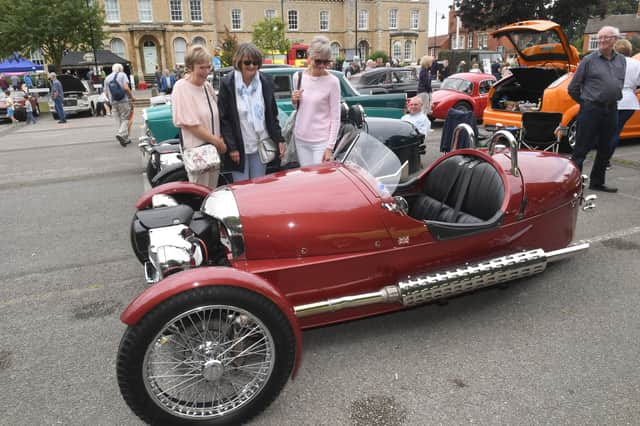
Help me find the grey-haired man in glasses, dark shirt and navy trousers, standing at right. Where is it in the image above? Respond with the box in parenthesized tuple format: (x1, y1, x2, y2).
(569, 26, 627, 192)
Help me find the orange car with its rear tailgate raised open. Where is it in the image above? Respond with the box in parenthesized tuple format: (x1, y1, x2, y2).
(483, 21, 640, 152)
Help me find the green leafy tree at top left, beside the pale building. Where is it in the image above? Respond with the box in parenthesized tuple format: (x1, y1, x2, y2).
(0, 0, 105, 72)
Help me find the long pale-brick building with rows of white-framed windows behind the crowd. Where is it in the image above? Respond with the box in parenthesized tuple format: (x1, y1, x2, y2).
(99, 0, 429, 80)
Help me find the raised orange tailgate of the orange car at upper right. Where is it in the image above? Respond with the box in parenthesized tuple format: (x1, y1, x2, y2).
(491, 20, 580, 71)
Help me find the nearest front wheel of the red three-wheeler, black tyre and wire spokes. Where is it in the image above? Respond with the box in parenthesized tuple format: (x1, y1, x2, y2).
(116, 286, 295, 425)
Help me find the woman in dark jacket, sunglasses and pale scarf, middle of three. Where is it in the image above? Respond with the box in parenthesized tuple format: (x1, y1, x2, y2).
(218, 43, 284, 182)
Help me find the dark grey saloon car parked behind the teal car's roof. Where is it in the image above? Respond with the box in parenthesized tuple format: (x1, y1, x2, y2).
(349, 67, 419, 98)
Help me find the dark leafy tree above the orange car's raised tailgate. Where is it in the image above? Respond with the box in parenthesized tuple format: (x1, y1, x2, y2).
(455, 0, 608, 45)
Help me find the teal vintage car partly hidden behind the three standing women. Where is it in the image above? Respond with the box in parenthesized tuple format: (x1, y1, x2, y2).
(143, 68, 407, 142)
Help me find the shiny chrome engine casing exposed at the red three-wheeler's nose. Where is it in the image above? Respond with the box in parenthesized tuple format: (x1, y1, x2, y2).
(144, 225, 204, 284)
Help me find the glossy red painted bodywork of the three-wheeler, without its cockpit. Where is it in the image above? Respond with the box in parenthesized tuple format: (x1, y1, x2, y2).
(127, 145, 582, 328)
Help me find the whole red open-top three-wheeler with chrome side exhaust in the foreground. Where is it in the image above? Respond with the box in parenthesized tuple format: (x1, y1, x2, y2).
(116, 130, 589, 425)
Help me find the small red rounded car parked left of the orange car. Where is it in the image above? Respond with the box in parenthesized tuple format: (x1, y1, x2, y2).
(429, 72, 496, 121)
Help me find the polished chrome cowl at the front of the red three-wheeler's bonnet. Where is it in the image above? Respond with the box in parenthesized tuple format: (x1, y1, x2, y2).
(200, 187, 245, 258)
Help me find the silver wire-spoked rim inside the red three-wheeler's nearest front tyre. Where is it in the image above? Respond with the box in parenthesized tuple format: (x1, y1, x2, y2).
(143, 305, 275, 418)
